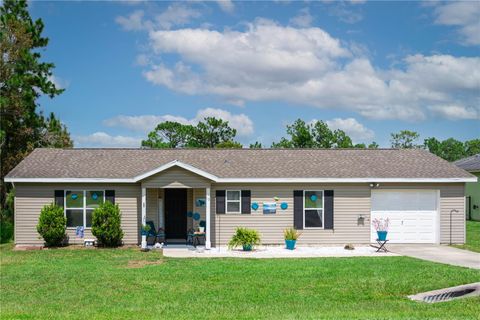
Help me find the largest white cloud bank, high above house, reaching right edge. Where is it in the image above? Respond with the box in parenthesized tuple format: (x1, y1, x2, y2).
(137, 19, 480, 121)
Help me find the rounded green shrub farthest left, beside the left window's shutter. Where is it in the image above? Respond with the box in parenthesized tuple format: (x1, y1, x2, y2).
(37, 203, 67, 247)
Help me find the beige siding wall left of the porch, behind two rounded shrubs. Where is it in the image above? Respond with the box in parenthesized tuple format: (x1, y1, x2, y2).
(15, 183, 141, 245)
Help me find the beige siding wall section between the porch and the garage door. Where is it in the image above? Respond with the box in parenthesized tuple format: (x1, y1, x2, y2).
(211, 184, 370, 245)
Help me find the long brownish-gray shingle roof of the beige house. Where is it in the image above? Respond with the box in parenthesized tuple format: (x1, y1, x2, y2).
(3, 149, 472, 179)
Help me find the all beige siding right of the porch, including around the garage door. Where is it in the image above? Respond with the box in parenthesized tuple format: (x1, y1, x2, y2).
(211, 183, 465, 245)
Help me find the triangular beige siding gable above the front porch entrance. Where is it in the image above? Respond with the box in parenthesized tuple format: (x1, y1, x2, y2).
(142, 167, 210, 188)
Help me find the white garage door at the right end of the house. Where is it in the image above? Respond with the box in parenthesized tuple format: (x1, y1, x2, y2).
(371, 190, 438, 243)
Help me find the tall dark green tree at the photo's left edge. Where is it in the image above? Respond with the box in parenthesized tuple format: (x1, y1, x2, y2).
(0, 0, 72, 238)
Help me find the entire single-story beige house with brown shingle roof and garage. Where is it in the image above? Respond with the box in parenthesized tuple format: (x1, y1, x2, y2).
(5, 149, 477, 247)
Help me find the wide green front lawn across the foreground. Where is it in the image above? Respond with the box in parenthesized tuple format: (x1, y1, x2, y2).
(0, 244, 480, 320)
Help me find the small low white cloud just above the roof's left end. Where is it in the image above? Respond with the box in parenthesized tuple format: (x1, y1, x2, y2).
(73, 132, 142, 148)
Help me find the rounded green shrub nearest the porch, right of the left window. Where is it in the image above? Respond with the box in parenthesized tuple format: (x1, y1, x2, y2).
(92, 201, 123, 247)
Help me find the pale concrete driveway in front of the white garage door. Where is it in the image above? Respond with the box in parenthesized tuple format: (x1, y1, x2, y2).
(388, 244, 480, 269)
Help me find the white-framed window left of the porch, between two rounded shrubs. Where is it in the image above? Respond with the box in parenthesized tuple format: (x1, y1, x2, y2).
(65, 190, 105, 228)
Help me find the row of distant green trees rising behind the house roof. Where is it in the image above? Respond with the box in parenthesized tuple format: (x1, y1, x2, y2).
(142, 117, 480, 161)
